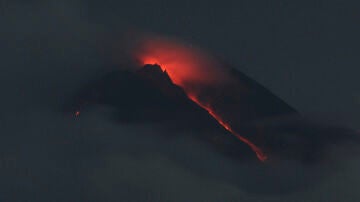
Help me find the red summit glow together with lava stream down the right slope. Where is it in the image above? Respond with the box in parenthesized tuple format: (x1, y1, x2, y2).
(136, 40, 267, 161)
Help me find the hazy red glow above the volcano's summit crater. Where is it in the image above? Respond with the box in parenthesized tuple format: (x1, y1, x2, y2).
(136, 39, 226, 87)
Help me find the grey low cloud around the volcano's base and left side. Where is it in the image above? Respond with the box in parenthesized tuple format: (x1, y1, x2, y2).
(0, 0, 360, 201)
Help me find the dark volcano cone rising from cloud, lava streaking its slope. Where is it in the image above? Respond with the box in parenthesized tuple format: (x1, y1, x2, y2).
(66, 64, 358, 162)
